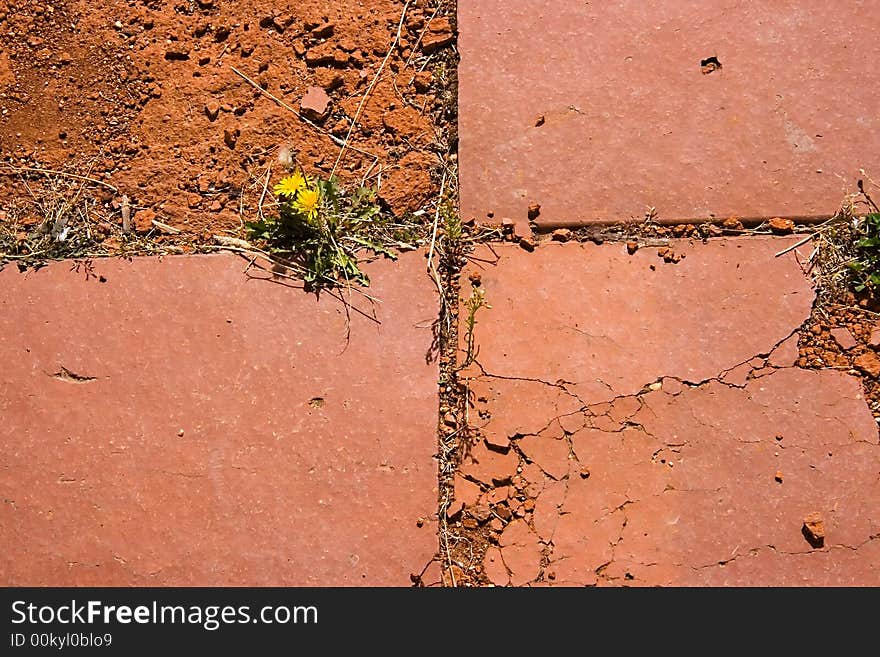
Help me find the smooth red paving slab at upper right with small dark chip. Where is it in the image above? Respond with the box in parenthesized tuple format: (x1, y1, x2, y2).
(458, 0, 880, 227)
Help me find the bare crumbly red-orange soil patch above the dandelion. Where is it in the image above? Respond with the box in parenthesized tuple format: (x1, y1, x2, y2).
(0, 0, 453, 234)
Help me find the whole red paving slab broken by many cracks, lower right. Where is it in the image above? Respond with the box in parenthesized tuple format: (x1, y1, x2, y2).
(454, 238, 880, 586)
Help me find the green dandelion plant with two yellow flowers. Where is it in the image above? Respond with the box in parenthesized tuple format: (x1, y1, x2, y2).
(246, 171, 396, 289)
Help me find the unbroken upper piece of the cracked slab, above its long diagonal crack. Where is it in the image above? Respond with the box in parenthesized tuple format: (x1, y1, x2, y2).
(460, 237, 814, 400)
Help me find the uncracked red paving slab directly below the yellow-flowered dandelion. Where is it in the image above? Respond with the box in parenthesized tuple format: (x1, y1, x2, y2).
(0, 254, 438, 586)
